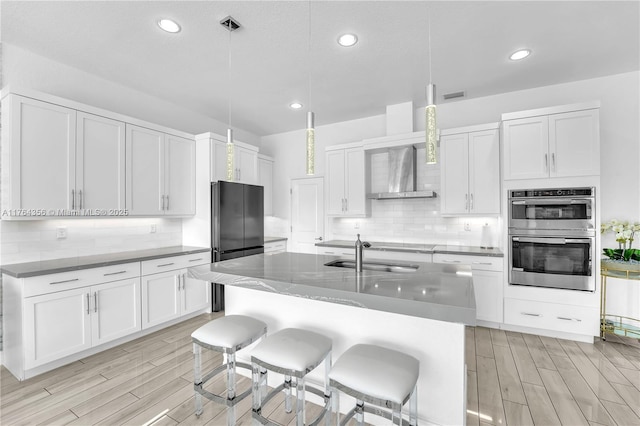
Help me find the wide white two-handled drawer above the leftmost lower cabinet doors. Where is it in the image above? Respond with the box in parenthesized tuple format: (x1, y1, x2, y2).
(24, 262, 140, 297)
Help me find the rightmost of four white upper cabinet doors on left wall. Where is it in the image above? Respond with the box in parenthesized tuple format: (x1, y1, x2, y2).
(164, 135, 196, 215)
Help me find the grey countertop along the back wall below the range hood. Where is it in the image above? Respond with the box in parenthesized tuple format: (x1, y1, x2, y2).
(316, 240, 504, 257)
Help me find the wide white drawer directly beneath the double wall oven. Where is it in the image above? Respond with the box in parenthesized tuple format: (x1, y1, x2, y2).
(504, 298, 599, 336)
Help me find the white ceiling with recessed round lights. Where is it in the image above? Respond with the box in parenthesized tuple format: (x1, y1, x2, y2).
(1, 0, 640, 135)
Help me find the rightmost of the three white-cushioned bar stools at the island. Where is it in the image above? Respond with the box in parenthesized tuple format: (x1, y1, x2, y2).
(329, 344, 420, 426)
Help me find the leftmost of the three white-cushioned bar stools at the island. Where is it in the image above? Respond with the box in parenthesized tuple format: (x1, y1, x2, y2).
(191, 315, 267, 426)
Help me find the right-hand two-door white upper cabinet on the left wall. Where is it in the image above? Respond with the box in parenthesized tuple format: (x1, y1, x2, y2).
(126, 124, 195, 216)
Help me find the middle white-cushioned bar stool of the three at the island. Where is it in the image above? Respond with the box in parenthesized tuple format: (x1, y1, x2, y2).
(251, 328, 332, 426)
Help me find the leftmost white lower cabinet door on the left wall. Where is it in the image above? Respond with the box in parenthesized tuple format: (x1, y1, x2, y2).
(24, 288, 91, 370)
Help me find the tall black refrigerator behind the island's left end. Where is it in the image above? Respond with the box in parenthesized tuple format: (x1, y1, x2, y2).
(211, 181, 264, 312)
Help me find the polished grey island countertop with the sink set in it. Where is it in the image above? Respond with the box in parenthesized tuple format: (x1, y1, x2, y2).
(188, 253, 476, 325)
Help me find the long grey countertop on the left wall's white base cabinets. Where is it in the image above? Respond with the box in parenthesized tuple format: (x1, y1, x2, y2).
(2, 246, 211, 278)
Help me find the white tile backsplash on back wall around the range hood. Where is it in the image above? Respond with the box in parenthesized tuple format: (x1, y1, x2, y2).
(326, 148, 502, 247)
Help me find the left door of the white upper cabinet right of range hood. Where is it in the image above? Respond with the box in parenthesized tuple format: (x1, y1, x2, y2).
(440, 133, 469, 214)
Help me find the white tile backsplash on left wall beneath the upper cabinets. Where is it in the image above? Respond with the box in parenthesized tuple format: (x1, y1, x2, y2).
(0, 218, 182, 265)
